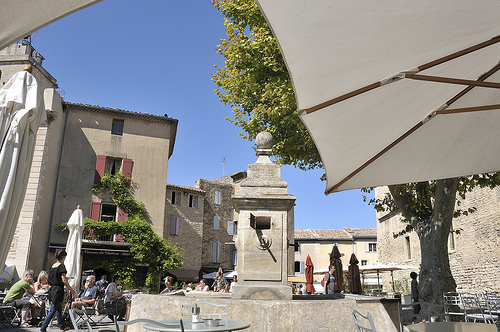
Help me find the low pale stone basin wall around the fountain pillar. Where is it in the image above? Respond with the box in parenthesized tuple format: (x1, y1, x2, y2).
(128, 292, 399, 332)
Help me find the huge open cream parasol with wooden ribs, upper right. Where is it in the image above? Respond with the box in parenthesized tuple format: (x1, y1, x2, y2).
(257, 0, 500, 193)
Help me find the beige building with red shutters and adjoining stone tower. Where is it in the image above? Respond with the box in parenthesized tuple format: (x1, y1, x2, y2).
(0, 43, 178, 278)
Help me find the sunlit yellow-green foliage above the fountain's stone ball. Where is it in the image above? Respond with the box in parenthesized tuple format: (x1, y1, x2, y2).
(212, 0, 322, 170)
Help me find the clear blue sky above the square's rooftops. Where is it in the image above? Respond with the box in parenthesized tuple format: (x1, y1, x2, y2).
(32, 0, 376, 229)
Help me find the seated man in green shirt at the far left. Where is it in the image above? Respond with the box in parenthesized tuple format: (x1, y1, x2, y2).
(3, 270, 35, 327)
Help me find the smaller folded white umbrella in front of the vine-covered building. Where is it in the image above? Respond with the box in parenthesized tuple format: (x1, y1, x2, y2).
(64, 206, 85, 291)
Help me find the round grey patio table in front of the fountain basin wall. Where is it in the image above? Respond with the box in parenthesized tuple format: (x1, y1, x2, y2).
(143, 319, 250, 332)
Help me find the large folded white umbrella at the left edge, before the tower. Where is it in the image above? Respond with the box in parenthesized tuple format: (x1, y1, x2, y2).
(0, 67, 46, 266)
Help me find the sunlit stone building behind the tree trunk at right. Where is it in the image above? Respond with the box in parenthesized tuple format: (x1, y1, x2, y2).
(376, 187, 500, 293)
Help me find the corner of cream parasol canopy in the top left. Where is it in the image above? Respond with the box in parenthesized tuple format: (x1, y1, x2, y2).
(0, 0, 102, 50)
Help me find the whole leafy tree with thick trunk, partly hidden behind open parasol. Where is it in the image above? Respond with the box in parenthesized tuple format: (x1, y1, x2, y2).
(212, 0, 499, 303)
